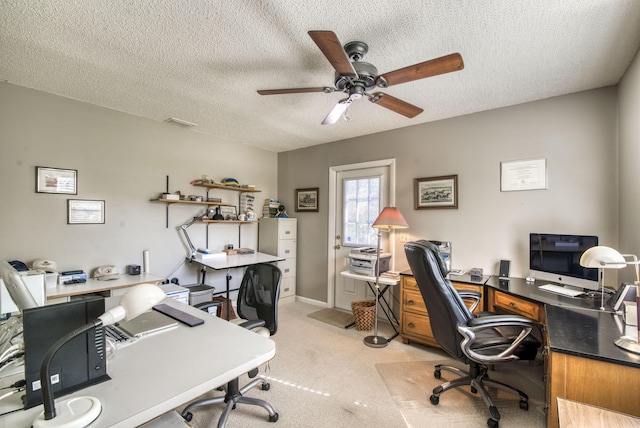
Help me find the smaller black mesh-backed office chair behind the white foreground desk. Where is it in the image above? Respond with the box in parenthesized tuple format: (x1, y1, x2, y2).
(182, 263, 282, 428)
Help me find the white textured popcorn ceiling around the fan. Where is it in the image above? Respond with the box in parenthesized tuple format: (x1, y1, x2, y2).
(0, 0, 640, 152)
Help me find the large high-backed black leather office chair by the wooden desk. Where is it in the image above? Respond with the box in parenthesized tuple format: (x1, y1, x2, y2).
(404, 240, 540, 428)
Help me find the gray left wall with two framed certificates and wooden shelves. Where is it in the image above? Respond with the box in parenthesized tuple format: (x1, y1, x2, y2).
(0, 83, 277, 285)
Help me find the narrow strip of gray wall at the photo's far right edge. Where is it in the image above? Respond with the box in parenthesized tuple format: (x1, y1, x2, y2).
(618, 46, 640, 281)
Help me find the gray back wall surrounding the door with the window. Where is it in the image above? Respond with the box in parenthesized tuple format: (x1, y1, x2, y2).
(278, 87, 620, 301)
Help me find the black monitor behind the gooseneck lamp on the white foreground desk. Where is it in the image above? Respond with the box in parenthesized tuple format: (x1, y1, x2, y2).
(22, 297, 110, 409)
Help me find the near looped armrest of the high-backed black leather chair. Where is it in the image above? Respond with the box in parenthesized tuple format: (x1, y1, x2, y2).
(458, 315, 536, 364)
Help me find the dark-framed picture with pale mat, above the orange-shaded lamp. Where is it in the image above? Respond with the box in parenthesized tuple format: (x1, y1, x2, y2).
(413, 175, 458, 210)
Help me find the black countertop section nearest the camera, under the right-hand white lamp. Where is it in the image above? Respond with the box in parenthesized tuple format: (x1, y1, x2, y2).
(545, 305, 640, 368)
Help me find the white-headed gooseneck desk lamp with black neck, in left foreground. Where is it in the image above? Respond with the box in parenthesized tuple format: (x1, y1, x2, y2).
(32, 284, 166, 428)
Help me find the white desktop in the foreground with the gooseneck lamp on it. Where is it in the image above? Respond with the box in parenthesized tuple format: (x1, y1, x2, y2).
(0, 298, 275, 428)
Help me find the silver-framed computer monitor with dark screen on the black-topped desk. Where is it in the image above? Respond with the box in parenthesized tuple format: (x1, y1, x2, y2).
(529, 233, 599, 291)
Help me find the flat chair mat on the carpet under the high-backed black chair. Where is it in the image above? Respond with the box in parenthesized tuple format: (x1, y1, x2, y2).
(376, 360, 546, 428)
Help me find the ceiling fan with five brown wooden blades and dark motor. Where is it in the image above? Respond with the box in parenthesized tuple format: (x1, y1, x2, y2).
(258, 30, 464, 125)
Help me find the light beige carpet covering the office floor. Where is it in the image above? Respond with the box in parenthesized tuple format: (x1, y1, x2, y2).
(169, 302, 545, 428)
